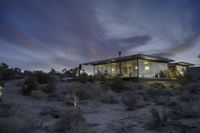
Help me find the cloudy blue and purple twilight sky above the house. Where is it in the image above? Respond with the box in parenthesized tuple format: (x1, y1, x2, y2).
(0, 0, 200, 70)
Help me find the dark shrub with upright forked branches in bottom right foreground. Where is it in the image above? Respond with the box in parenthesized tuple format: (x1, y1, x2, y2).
(146, 108, 170, 131)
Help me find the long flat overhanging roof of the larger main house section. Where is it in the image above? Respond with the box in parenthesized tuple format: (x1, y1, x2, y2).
(83, 54, 174, 65)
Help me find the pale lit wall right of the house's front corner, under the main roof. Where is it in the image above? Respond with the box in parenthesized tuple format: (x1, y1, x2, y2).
(138, 59, 168, 78)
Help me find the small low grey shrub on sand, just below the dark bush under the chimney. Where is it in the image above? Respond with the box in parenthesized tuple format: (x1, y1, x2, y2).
(101, 90, 117, 104)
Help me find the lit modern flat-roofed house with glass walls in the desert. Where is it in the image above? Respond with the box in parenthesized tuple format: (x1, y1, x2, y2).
(83, 54, 193, 79)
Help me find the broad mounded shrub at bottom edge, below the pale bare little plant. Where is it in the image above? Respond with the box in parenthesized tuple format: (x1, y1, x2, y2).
(53, 110, 95, 133)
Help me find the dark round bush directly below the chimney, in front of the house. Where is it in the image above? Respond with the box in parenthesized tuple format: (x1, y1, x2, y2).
(110, 78, 126, 92)
